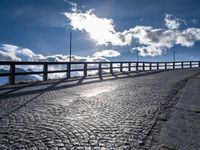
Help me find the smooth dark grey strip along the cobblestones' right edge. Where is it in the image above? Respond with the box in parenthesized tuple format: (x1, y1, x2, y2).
(158, 75, 200, 150)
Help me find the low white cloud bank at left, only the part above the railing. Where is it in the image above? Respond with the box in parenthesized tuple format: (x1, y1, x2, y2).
(0, 44, 111, 62)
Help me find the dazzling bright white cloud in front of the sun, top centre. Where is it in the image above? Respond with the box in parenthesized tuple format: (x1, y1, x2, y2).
(64, 9, 127, 45)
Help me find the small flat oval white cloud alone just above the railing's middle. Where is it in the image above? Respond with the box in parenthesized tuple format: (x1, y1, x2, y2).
(93, 50, 120, 57)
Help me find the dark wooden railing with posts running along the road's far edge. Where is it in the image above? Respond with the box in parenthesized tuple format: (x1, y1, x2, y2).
(0, 61, 200, 84)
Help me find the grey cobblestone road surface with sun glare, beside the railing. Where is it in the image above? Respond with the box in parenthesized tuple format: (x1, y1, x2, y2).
(0, 69, 199, 150)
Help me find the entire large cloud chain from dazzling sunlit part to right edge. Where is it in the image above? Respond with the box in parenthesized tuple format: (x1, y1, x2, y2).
(64, 9, 200, 56)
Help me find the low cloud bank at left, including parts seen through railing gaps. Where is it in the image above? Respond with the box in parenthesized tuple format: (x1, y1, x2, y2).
(0, 44, 111, 84)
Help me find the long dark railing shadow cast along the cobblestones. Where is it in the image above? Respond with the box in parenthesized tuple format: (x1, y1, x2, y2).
(0, 70, 167, 99)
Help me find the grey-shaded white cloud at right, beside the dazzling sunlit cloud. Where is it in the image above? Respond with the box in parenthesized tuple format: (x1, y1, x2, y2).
(129, 26, 200, 56)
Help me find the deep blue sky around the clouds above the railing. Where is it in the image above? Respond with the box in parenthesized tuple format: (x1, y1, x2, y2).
(0, 0, 200, 61)
